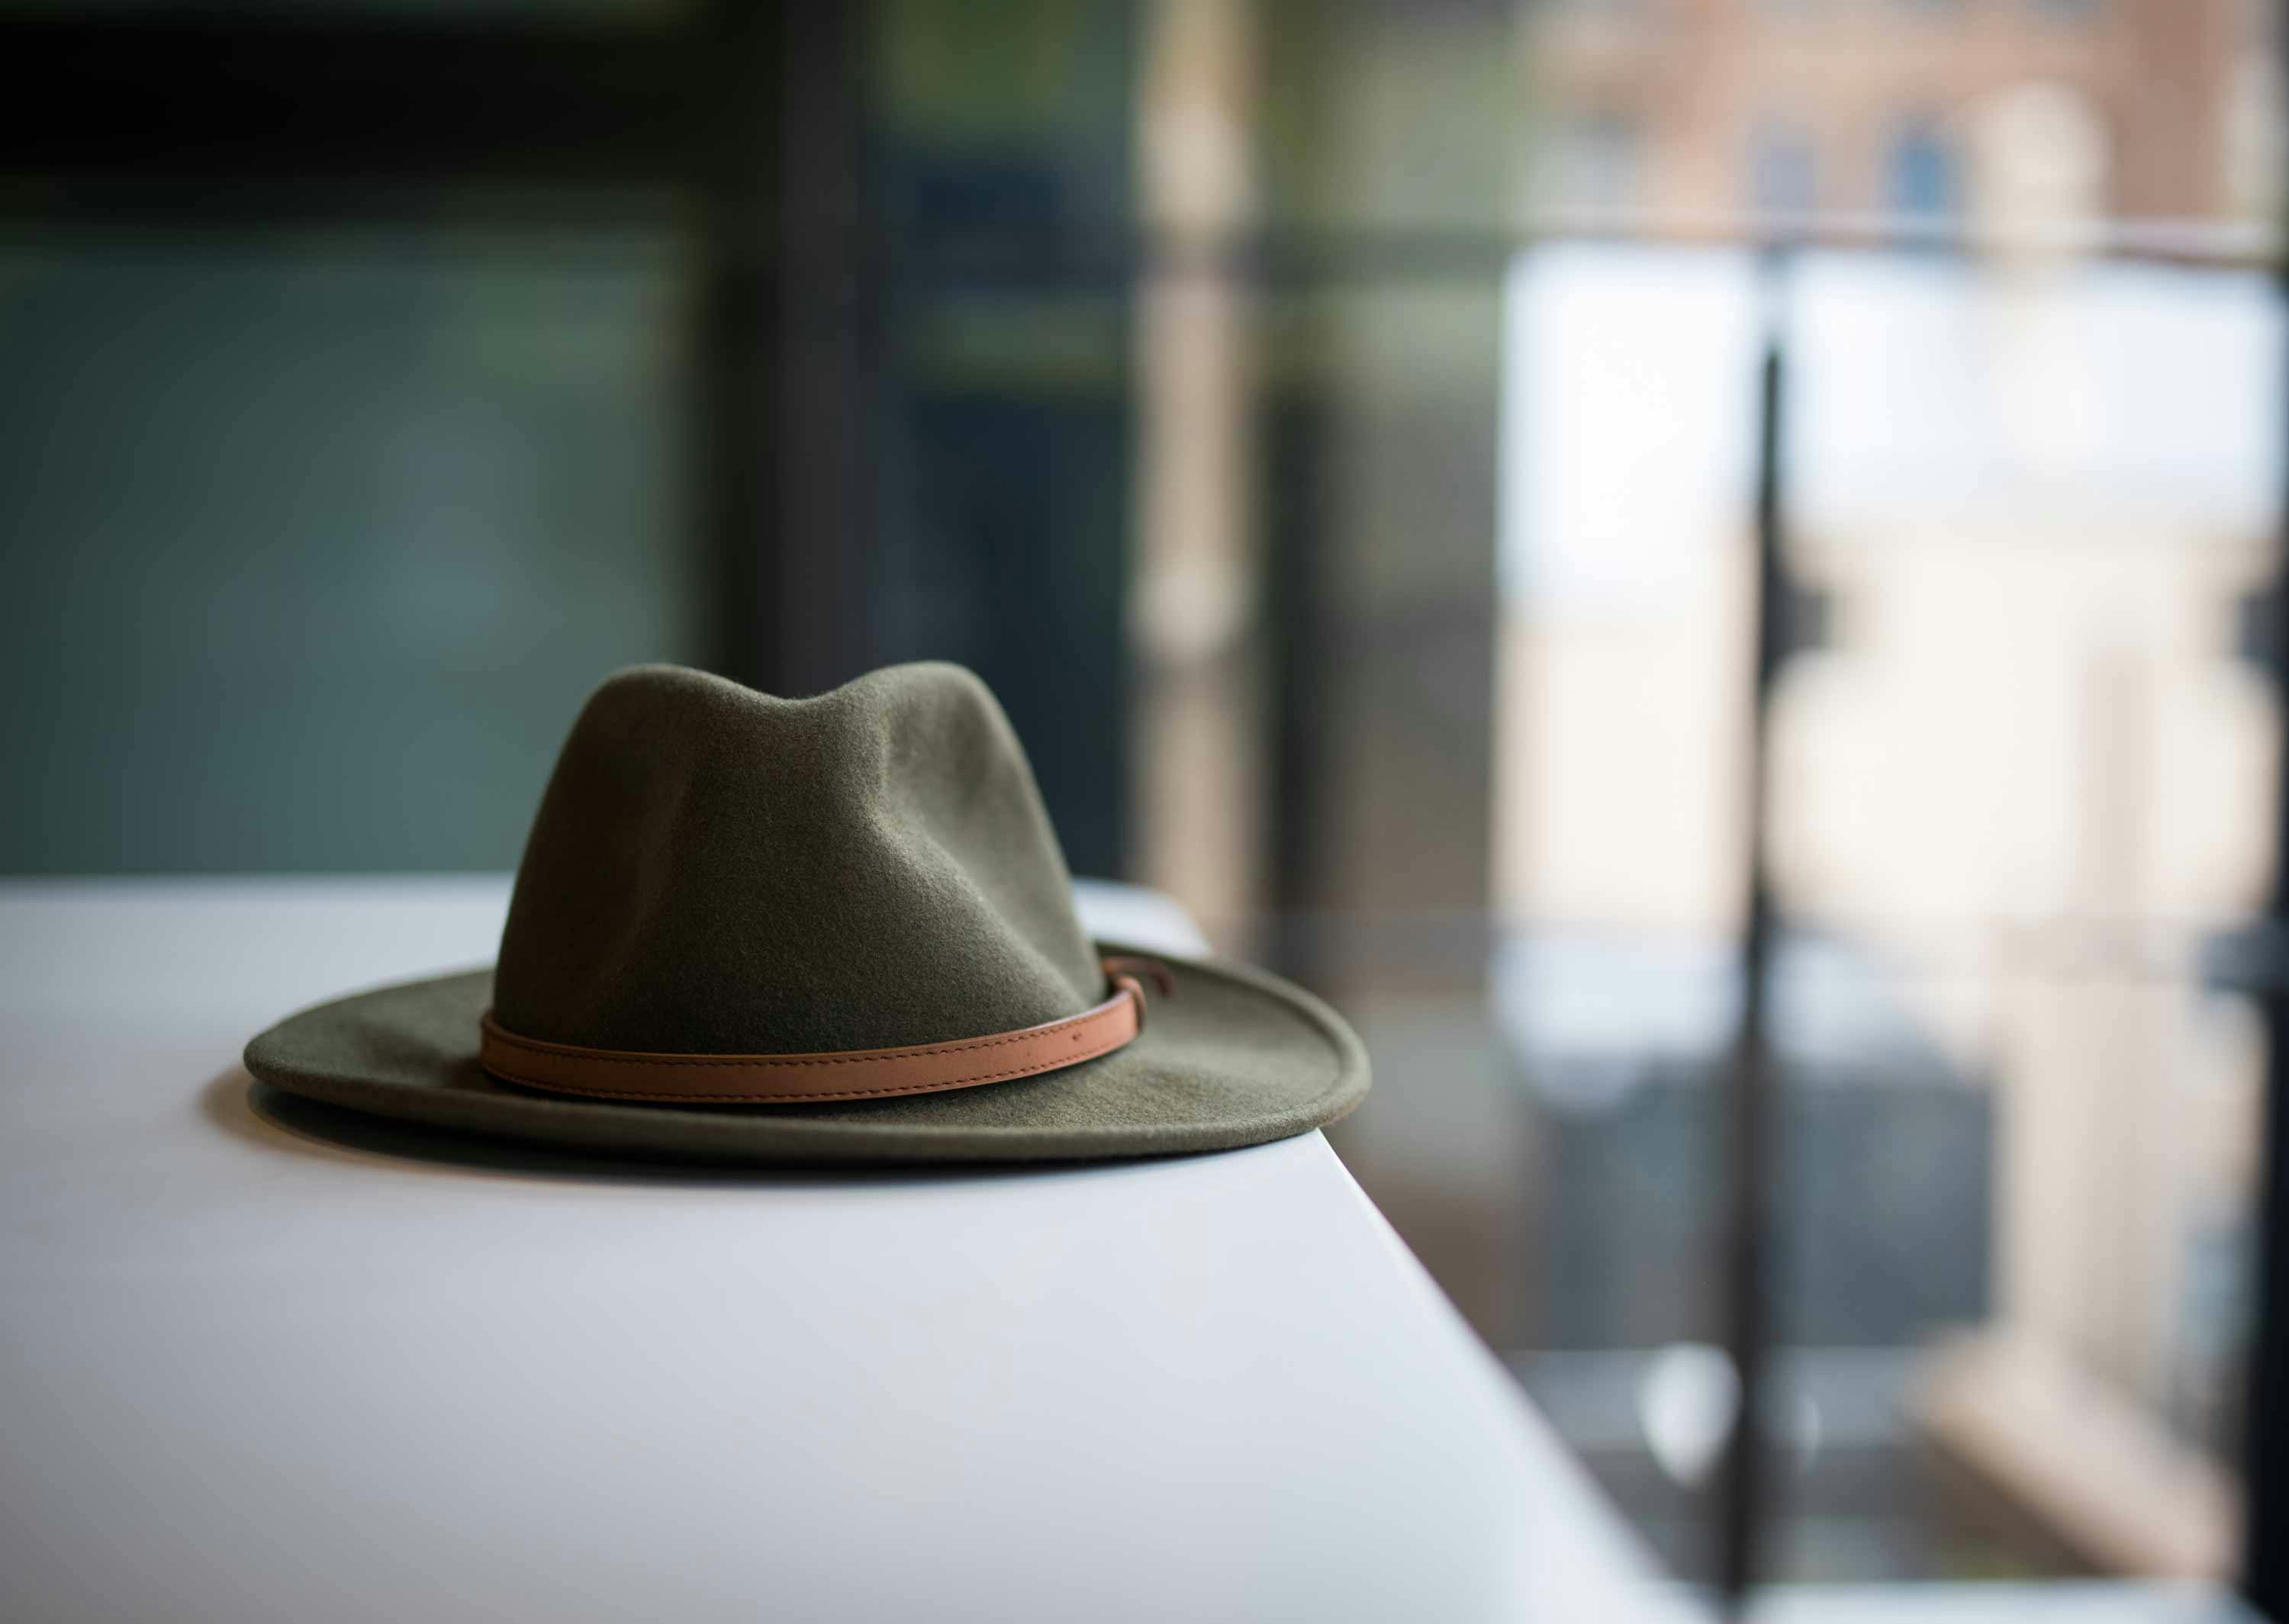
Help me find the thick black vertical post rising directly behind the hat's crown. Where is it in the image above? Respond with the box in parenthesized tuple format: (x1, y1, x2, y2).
(694, 0, 879, 693)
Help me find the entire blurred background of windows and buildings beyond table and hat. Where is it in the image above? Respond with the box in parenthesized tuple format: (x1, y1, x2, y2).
(0, 0, 2289, 1615)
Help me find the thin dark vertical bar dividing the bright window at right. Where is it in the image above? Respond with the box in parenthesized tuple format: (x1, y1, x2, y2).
(1717, 249, 1788, 1615)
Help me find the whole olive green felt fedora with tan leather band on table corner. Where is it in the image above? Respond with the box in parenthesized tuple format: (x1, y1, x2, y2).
(245, 664, 1367, 1162)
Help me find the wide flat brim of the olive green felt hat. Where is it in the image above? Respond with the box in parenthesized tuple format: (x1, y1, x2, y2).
(245, 942, 1369, 1164)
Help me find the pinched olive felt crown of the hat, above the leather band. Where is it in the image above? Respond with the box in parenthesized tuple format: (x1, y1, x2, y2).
(494, 664, 1103, 1054)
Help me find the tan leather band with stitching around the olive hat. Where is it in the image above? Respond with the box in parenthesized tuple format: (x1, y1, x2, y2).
(478, 963, 1144, 1105)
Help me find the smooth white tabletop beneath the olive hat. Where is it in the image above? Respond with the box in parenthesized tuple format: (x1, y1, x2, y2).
(0, 878, 1671, 1624)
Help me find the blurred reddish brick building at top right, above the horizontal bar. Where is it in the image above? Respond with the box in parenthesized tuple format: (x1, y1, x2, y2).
(1527, 0, 2278, 230)
